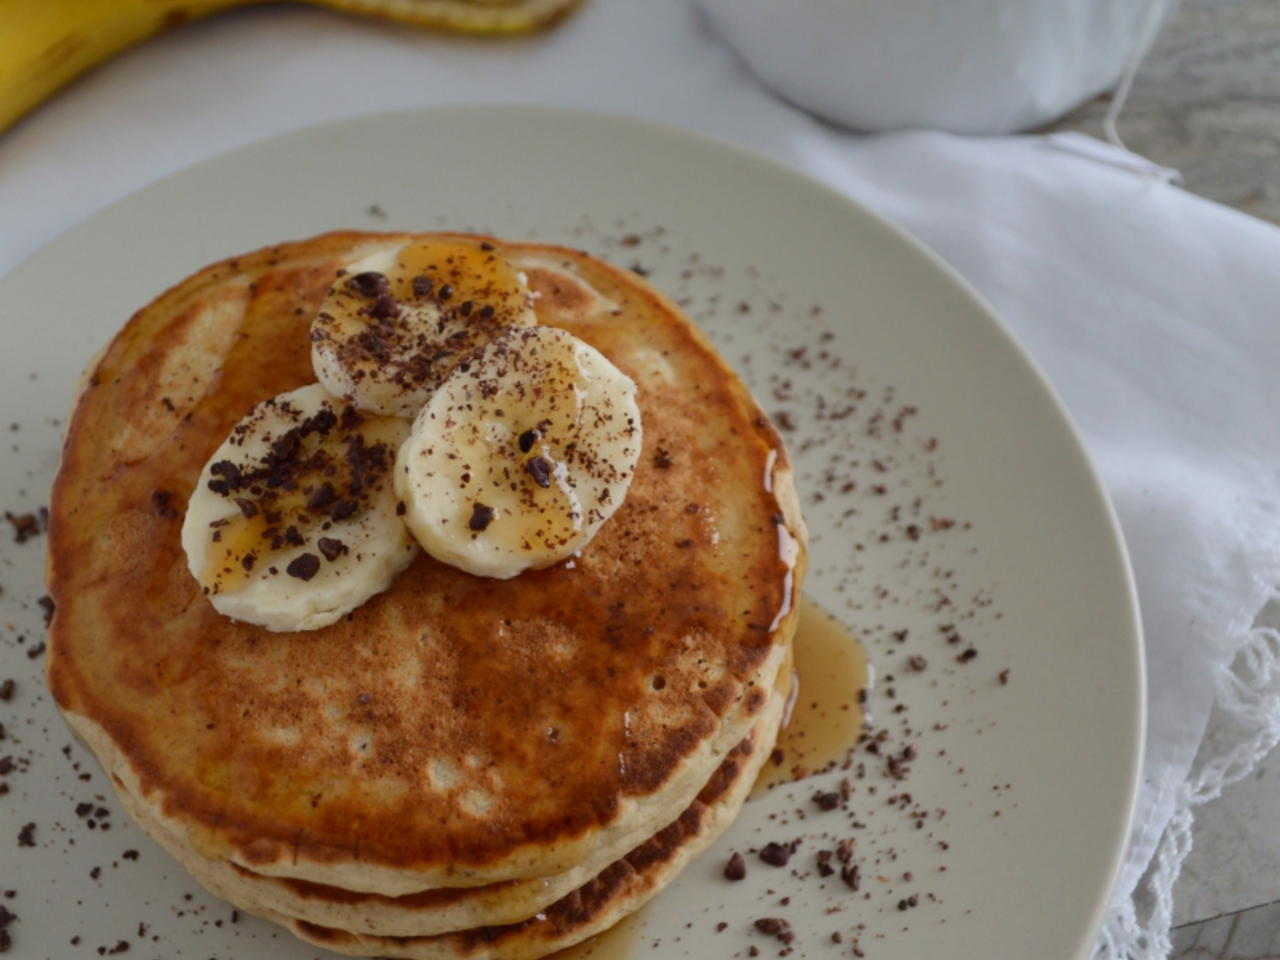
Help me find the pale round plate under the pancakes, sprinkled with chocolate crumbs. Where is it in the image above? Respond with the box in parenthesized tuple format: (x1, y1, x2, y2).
(0, 108, 1143, 960)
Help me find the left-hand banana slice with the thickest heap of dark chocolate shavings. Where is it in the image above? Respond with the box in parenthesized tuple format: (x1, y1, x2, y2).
(182, 384, 417, 631)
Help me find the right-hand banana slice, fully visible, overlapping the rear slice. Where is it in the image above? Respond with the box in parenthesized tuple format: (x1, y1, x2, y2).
(396, 326, 641, 580)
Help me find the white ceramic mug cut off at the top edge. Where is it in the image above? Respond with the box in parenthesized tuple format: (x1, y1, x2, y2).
(699, 0, 1178, 133)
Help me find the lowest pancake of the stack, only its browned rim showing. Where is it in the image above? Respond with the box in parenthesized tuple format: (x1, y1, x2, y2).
(107, 655, 791, 960)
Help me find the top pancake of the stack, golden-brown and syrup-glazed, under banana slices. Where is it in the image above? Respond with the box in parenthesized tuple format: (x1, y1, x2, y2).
(49, 233, 804, 896)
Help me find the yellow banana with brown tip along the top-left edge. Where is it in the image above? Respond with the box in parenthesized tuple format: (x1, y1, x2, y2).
(0, 0, 581, 131)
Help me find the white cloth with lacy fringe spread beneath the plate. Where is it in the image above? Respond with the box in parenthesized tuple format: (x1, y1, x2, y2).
(0, 0, 1280, 957)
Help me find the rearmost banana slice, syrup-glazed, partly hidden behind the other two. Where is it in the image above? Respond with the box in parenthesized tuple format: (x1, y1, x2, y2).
(311, 238, 536, 420)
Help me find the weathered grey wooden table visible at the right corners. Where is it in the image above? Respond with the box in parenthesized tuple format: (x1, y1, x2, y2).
(1053, 0, 1280, 960)
